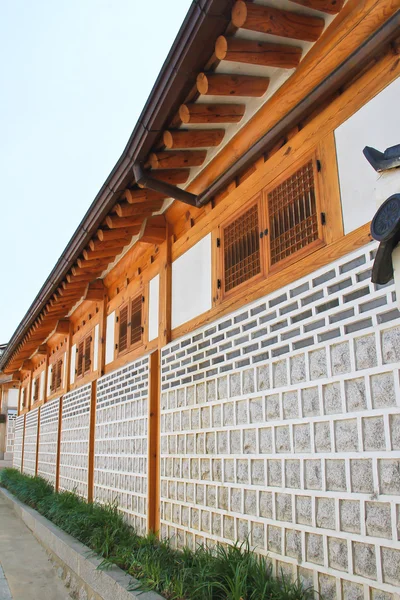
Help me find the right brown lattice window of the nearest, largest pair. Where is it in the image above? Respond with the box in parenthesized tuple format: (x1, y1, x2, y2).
(267, 160, 319, 265)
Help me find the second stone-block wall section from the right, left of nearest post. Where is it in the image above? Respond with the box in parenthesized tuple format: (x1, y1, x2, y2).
(94, 357, 149, 533)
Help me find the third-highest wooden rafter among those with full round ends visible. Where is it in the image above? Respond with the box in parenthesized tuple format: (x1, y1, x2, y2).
(196, 73, 269, 98)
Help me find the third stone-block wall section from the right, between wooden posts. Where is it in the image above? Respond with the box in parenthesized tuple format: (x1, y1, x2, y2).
(59, 384, 91, 498)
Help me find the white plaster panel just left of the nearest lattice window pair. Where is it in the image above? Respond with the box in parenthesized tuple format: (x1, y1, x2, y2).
(171, 234, 211, 328)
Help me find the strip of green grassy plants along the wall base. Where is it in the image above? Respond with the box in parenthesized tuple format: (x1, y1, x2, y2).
(0, 469, 315, 600)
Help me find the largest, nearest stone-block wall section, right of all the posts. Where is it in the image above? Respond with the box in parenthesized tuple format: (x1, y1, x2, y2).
(161, 244, 400, 600)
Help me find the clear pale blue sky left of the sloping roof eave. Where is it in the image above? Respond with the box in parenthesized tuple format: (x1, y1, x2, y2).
(0, 0, 191, 343)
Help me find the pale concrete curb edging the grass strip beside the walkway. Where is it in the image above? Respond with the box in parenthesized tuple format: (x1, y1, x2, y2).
(0, 488, 165, 600)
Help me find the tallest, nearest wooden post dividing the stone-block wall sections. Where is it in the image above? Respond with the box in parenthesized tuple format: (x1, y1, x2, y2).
(147, 350, 160, 533)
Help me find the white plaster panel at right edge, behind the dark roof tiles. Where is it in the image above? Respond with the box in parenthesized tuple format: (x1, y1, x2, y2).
(335, 79, 400, 233)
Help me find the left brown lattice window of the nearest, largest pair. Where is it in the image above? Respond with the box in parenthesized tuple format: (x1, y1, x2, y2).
(222, 203, 261, 292)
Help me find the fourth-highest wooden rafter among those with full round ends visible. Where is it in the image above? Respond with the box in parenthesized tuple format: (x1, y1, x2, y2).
(180, 103, 246, 124)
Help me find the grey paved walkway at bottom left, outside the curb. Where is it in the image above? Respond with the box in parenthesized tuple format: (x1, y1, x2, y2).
(0, 496, 71, 600)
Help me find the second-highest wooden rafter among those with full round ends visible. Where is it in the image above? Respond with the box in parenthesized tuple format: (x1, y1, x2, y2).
(215, 35, 303, 69)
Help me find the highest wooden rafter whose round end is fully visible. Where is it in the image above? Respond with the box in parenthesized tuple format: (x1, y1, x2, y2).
(231, 0, 325, 42)
